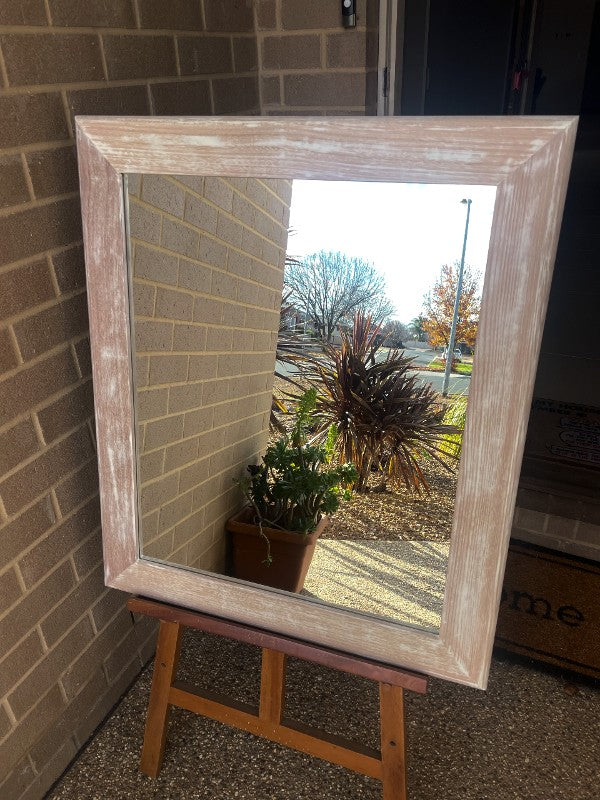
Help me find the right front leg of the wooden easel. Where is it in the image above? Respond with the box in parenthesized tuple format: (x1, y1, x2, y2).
(379, 683, 406, 800)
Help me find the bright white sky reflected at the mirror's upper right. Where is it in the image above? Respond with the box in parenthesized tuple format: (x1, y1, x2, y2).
(288, 180, 496, 323)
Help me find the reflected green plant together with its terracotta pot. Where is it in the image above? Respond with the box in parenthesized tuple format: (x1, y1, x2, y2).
(227, 389, 357, 592)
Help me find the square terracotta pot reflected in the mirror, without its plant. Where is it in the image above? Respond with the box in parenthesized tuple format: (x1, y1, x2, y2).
(226, 506, 329, 592)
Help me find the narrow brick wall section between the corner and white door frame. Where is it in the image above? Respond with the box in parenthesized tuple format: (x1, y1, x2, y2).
(257, 0, 379, 115)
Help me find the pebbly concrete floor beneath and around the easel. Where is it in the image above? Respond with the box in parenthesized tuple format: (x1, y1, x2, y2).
(48, 632, 600, 800)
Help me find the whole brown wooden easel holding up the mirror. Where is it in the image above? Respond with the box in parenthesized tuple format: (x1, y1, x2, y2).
(128, 597, 427, 800)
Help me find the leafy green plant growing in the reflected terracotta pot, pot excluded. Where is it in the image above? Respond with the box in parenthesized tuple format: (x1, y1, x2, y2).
(239, 389, 356, 563)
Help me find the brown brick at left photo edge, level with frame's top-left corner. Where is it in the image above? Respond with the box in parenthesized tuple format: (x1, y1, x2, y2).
(0, 92, 69, 147)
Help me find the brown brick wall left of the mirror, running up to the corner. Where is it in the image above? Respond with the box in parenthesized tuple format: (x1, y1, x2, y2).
(0, 0, 258, 800)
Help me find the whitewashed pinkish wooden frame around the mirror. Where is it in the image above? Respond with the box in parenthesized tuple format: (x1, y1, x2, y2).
(77, 117, 576, 688)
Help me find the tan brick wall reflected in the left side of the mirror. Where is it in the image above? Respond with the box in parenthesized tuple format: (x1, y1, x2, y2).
(129, 175, 292, 572)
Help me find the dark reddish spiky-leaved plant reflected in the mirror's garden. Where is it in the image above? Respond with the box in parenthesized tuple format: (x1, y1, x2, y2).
(304, 312, 457, 493)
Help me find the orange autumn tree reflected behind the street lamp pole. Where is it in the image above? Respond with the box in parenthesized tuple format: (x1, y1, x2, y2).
(422, 261, 481, 347)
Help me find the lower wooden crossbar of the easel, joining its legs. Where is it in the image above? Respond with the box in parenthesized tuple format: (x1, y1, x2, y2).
(169, 681, 381, 780)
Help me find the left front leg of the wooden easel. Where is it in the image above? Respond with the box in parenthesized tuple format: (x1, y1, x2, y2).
(140, 620, 181, 778)
